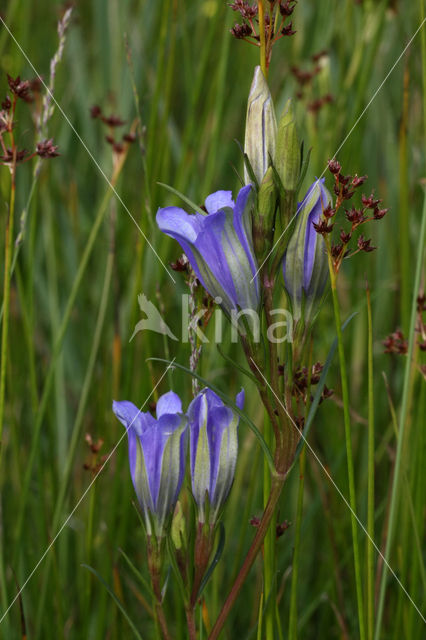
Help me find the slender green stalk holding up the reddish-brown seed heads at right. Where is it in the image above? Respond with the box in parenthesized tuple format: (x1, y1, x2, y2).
(328, 251, 365, 640)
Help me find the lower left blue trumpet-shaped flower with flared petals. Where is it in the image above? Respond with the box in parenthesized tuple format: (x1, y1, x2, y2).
(112, 391, 187, 537)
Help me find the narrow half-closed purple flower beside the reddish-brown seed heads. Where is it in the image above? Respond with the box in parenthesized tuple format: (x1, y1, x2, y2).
(283, 179, 331, 321)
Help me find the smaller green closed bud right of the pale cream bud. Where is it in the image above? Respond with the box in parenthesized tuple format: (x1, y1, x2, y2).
(275, 99, 300, 193)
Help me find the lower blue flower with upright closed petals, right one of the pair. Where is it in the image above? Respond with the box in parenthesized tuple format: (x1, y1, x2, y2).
(187, 389, 244, 524)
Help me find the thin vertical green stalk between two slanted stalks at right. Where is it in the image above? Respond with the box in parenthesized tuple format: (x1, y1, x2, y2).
(366, 284, 375, 640)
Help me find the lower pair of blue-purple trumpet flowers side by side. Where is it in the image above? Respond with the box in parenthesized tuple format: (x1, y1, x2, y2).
(113, 389, 244, 538)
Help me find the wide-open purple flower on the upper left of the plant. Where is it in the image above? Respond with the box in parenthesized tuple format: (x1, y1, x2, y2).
(157, 185, 259, 315)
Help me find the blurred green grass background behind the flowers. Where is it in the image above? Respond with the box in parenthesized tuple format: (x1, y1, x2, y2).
(0, 0, 426, 640)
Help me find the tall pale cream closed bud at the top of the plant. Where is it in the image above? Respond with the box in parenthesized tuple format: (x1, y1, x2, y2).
(244, 67, 277, 185)
